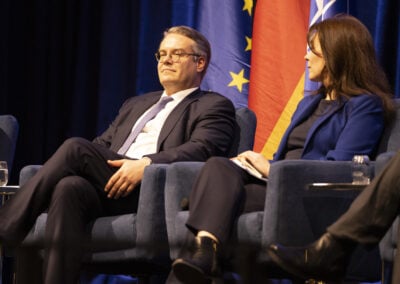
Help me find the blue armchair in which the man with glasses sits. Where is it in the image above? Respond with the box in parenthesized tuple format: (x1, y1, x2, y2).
(16, 108, 256, 281)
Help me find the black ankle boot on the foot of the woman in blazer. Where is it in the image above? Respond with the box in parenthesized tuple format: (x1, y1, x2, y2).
(172, 237, 220, 284)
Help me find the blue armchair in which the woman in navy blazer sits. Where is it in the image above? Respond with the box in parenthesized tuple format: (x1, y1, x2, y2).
(165, 101, 400, 282)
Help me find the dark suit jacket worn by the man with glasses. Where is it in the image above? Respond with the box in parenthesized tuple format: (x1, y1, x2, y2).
(94, 89, 238, 163)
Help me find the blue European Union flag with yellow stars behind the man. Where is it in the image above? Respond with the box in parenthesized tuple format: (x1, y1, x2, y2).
(197, 0, 253, 107)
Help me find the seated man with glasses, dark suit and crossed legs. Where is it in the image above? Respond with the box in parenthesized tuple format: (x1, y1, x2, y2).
(0, 26, 237, 283)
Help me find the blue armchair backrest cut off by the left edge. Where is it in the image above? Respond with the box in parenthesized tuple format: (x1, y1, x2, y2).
(0, 115, 19, 172)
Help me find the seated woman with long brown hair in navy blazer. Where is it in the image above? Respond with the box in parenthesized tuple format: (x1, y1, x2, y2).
(170, 15, 393, 283)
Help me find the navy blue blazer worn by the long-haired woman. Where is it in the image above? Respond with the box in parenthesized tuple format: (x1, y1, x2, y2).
(274, 92, 385, 161)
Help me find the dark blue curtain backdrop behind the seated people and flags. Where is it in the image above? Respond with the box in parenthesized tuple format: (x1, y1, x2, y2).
(0, 0, 400, 183)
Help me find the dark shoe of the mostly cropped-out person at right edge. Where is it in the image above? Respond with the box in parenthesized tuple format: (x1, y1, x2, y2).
(268, 233, 355, 281)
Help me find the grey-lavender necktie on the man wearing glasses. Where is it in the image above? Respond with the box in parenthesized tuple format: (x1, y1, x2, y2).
(118, 96, 173, 155)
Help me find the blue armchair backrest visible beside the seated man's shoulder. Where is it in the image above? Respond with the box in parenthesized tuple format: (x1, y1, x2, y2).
(236, 107, 257, 154)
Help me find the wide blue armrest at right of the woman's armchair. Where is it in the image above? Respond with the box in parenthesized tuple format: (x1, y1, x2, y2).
(262, 160, 381, 282)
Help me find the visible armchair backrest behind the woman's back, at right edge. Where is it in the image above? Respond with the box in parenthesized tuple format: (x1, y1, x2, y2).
(378, 99, 400, 154)
